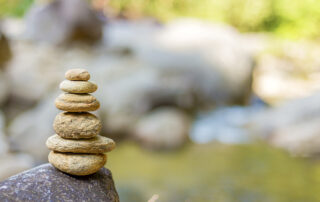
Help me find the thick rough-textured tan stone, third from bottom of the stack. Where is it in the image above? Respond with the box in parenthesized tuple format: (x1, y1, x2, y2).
(53, 112, 101, 139)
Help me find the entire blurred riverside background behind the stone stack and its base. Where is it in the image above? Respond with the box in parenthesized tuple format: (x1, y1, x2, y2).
(0, 0, 320, 202)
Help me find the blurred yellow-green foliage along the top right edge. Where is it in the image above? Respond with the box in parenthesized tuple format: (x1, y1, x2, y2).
(110, 0, 320, 38)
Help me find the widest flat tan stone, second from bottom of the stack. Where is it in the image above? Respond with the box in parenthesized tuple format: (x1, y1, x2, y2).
(46, 134, 115, 154)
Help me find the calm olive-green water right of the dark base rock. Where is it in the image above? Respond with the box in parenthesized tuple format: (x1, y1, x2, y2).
(107, 142, 320, 202)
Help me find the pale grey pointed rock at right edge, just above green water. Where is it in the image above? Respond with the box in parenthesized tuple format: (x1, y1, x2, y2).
(249, 92, 320, 156)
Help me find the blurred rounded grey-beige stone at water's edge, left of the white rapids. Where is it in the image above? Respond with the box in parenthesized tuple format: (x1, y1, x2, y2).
(133, 108, 190, 149)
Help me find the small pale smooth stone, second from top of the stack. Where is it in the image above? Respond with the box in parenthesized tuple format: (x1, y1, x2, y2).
(60, 80, 98, 93)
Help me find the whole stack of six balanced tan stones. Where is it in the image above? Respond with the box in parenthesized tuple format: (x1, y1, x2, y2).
(46, 69, 115, 176)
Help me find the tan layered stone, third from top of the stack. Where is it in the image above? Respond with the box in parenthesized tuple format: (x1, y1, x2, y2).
(55, 93, 100, 112)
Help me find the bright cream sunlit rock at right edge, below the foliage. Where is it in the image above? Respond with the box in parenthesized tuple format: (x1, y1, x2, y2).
(252, 39, 320, 105)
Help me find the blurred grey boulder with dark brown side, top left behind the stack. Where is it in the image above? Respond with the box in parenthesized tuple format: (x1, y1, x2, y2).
(26, 0, 102, 44)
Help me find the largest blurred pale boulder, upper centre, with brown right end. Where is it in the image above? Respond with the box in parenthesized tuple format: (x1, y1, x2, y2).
(105, 19, 254, 104)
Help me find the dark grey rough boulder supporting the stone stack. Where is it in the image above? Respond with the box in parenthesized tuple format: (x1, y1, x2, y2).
(0, 163, 119, 202)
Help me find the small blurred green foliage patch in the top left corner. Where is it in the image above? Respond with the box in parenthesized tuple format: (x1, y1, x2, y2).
(0, 0, 34, 17)
